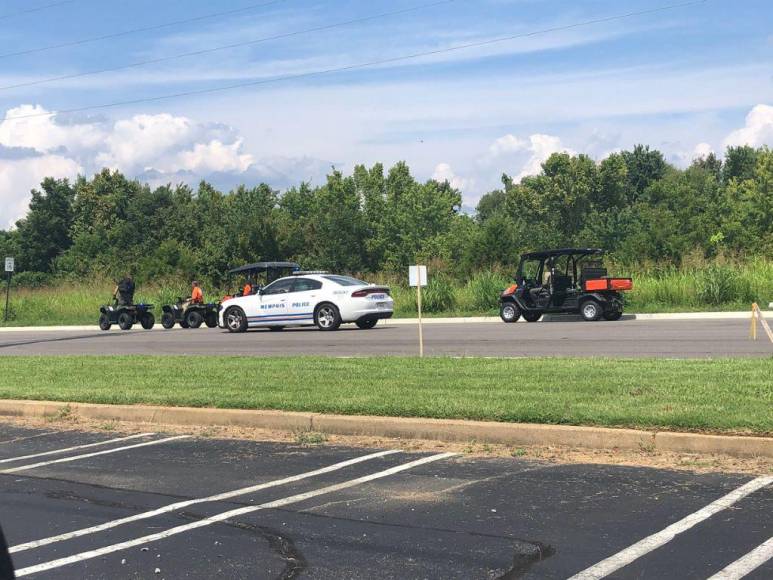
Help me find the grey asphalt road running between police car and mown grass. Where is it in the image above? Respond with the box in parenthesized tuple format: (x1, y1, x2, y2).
(0, 320, 773, 358)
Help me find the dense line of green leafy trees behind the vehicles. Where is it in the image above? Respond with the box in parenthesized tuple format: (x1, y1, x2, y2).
(0, 145, 773, 283)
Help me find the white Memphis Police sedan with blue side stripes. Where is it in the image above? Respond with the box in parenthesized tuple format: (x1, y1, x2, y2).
(220, 272, 394, 332)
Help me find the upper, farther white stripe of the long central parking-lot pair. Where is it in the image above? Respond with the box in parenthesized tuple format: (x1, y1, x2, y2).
(9, 449, 400, 554)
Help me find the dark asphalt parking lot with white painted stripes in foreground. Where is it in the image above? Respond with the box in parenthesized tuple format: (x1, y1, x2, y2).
(0, 423, 773, 579)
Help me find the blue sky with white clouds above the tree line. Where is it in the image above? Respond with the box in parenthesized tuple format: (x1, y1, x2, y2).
(0, 0, 773, 227)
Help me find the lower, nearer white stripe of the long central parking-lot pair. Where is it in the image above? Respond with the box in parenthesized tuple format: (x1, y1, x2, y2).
(16, 453, 456, 578)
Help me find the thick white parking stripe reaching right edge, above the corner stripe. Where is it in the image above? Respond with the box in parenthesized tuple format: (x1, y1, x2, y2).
(569, 475, 773, 580)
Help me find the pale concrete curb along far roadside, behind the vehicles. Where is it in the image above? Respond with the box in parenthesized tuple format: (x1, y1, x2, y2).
(0, 310, 773, 332)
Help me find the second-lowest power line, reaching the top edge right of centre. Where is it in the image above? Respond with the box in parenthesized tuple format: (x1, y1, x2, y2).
(0, 0, 457, 91)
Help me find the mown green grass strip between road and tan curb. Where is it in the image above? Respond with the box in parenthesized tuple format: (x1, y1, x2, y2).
(0, 356, 773, 435)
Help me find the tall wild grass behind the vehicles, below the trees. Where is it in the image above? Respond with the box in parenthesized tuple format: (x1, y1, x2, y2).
(0, 260, 773, 326)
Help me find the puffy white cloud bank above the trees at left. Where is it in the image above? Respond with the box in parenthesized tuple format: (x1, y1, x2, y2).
(0, 105, 325, 228)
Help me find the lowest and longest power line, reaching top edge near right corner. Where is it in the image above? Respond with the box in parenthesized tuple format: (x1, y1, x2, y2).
(2, 0, 708, 122)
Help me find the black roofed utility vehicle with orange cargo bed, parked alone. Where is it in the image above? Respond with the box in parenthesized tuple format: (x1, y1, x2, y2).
(499, 248, 633, 322)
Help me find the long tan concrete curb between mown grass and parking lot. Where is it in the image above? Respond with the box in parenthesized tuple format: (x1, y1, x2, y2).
(0, 400, 773, 458)
